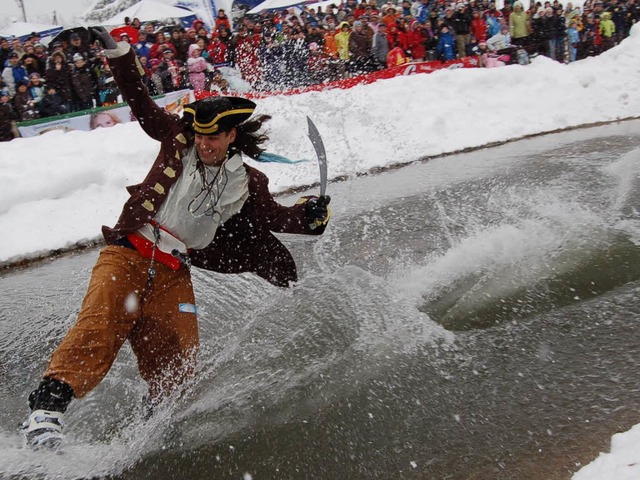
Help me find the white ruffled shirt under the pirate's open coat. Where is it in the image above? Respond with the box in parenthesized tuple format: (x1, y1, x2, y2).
(138, 146, 249, 253)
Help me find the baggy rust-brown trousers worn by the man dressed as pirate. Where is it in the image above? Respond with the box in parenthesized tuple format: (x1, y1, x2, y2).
(44, 246, 198, 399)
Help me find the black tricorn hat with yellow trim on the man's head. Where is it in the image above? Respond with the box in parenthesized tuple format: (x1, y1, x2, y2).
(183, 97, 256, 135)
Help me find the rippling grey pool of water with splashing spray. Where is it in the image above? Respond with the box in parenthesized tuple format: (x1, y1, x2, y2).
(0, 122, 640, 479)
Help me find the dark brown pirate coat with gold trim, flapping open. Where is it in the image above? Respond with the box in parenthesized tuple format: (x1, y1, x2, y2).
(102, 50, 324, 286)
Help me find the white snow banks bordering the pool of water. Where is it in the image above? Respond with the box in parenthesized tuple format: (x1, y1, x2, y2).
(0, 28, 640, 480)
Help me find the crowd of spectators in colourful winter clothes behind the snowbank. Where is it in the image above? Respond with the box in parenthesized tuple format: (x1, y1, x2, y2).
(0, 0, 640, 139)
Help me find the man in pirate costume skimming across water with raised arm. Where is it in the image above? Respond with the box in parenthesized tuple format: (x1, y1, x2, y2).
(25, 27, 330, 446)
